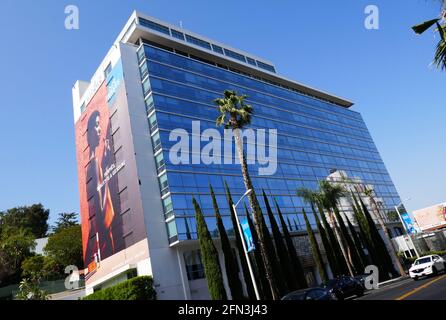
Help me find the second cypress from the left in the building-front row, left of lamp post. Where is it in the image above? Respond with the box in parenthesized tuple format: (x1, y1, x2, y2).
(210, 186, 245, 300)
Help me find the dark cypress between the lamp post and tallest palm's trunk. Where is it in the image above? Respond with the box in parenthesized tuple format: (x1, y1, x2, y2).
(243, 205, 273, 300)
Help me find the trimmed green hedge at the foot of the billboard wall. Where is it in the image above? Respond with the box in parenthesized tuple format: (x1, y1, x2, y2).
(83, 276, 156, 300)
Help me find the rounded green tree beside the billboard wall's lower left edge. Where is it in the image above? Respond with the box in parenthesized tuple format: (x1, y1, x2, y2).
(44, 225, 84, 270)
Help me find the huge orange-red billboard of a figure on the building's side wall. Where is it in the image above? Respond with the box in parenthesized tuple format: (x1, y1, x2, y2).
(76, 60, 146, 274)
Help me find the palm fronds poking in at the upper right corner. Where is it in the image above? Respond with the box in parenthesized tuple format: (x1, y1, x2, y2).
(412, 0, 446, 70)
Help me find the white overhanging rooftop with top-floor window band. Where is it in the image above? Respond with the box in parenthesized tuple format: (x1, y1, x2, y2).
(73, 11, 353, 119)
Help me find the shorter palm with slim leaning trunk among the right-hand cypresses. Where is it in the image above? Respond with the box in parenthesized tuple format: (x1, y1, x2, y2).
(319, 180, 354, 276)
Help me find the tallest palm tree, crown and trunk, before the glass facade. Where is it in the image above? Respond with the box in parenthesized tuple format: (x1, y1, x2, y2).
(214, 90, 280, 300)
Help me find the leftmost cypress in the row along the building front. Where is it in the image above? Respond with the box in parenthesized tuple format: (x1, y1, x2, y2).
(192, 198, 227, 300)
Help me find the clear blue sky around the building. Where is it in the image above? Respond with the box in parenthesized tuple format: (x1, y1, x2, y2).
(0, 0, 446, 225)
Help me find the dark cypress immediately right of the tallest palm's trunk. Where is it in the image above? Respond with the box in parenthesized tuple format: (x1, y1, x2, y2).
(262, 190, 299, 293)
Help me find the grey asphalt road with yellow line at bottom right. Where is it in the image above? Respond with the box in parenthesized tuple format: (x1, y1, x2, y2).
(357, 273, 446, 300)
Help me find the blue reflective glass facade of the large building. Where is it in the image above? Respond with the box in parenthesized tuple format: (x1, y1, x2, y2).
(138, 44, 400, 243)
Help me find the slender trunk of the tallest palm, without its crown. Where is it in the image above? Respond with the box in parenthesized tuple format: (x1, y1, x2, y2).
(233, 129, 280, 300)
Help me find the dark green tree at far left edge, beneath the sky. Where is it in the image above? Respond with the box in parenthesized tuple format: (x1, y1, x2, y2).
(0, 204, 50, 239)
